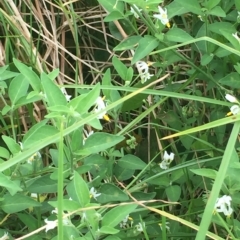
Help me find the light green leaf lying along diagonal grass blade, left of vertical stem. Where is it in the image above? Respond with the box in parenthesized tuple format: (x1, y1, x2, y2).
(23, 119, 58, 149)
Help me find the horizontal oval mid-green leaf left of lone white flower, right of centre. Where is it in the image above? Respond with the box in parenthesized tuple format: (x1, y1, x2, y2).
(117, 154, 147, 170)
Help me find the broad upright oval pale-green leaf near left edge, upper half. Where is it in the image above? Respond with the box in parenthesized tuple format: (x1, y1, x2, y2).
(8, 74, 29, 105)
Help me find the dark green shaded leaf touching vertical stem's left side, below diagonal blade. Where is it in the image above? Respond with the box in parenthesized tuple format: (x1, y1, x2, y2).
(27, 174, 57, 193)
